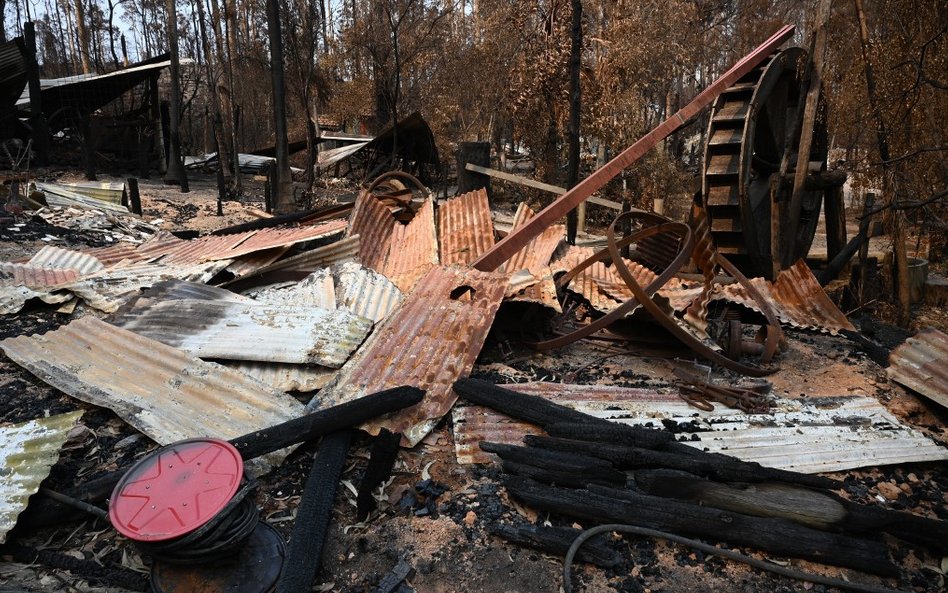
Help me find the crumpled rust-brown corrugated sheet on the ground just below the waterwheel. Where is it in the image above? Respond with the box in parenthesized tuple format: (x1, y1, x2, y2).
(711, 259, 856, 335)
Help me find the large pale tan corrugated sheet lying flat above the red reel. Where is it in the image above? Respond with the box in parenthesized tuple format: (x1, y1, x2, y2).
(0, 317, 304, 471)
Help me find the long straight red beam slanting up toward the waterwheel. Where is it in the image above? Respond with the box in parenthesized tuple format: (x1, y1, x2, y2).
(472, 25, 794, 272)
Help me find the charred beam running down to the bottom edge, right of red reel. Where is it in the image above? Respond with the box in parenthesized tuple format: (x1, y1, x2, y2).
(276, 430, 352, 593)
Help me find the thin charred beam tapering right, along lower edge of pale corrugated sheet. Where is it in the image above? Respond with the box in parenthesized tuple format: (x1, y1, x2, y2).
(524, 432, 841, 489)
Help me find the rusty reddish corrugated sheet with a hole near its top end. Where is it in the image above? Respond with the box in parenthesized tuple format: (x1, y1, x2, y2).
(309, 267, 507, 446)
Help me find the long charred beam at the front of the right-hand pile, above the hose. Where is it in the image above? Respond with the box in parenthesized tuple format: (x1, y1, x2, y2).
(505, 477, 899, 576)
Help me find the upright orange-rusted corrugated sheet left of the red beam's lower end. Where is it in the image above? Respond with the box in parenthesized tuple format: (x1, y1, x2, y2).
(438, 189, 494, 265)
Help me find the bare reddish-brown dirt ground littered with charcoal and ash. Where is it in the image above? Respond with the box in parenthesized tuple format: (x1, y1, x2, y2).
(0, 177, 948, 593)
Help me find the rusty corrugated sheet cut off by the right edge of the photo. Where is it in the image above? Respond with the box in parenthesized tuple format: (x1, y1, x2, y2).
(886, 327, 948, 408)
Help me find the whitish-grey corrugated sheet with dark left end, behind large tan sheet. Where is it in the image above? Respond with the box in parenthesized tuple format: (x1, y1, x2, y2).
(111, 299, 372, 368)
